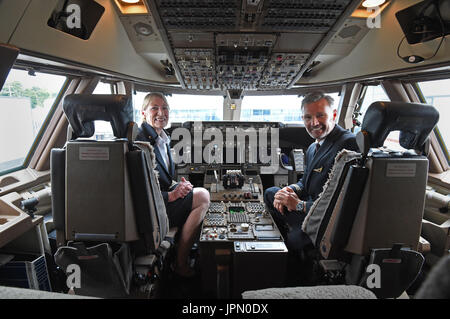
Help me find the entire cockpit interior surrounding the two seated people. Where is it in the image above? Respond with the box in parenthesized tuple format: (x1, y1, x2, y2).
(0, 0, 450, 302)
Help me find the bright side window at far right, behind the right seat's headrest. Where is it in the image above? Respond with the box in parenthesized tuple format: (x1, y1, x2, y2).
(419, 79, 450, 156)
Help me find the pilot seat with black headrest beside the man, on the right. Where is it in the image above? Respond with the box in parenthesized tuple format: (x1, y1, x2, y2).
(243, 102, 439, 298)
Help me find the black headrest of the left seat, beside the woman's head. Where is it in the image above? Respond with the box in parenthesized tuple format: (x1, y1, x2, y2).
(63, 94, 133, 139)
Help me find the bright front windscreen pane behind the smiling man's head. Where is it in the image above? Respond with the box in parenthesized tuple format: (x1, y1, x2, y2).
(241, 93, 340, 123)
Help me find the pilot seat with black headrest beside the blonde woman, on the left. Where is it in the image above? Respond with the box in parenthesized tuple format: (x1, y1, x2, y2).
(51, 94, 176, 298)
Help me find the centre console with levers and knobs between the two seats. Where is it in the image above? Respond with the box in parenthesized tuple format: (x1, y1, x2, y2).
(199, 166, 287, 298)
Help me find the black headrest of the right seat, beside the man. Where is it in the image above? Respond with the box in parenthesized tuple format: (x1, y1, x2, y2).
(357, 102, 439, 154)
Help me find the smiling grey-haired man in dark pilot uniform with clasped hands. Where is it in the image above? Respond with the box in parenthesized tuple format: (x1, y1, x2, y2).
(264, 92, 358, 252)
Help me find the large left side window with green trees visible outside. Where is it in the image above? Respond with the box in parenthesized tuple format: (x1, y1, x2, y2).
(0, 69, 66, 174)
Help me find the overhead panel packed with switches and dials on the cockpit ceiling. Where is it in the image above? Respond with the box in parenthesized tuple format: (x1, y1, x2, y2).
(148, 0, 355, 90)
